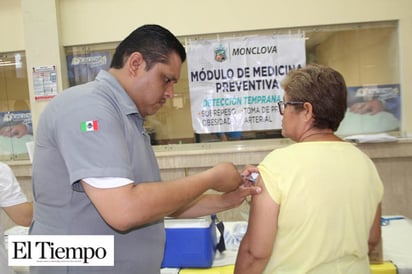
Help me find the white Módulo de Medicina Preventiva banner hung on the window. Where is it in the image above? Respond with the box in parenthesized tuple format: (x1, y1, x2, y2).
(187, 34, 306, 133)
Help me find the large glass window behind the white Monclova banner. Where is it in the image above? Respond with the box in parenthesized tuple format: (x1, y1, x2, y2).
(66, 22, 401, 144)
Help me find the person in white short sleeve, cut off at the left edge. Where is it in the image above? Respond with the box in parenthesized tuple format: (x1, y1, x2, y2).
(0, 162, 33, 274)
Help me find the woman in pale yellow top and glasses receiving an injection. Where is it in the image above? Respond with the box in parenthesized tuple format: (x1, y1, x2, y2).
(235, 64, 383, 274)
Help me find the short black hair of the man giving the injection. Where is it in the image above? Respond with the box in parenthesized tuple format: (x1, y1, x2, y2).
(110, 25, 186, 70)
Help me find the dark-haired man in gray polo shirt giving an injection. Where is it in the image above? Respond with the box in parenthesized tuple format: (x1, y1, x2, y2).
(30, 25, 260, 274)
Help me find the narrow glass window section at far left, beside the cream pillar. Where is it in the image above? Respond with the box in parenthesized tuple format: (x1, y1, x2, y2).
(0, 52, 33, 160)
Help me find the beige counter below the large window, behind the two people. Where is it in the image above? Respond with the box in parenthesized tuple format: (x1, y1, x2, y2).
(6, 138, 412, 226)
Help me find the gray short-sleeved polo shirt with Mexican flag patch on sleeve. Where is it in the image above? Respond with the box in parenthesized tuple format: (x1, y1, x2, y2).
(30, 71, 164, 274)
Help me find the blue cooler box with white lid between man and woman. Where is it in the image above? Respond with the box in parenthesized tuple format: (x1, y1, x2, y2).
(162, 217, 217, 268)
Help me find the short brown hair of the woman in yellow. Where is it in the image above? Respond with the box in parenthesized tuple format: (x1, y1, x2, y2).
(281, 64, 347, 131)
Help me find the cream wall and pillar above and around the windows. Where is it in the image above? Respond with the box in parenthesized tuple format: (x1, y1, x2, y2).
(0, 0, 412, 136)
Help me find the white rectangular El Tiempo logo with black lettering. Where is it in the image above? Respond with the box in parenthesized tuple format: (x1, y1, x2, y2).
(8, 235, 114, 266)
